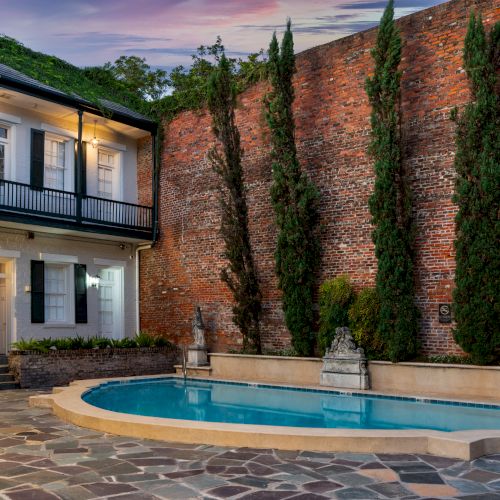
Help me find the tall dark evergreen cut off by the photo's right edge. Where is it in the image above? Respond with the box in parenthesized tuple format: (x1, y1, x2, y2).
(453, 13, 500, 364)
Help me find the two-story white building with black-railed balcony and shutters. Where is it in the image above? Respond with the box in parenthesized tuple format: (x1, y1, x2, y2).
(0, 64, 157, 354)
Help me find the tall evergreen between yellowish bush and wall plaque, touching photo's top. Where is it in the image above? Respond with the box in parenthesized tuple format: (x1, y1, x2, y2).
(366, 0, 419, 361)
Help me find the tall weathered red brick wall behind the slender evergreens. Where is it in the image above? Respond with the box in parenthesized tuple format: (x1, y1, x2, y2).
(140, 0, 500, 353)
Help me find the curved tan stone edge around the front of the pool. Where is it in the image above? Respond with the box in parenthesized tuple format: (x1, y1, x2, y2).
(30, 375, 500, 460)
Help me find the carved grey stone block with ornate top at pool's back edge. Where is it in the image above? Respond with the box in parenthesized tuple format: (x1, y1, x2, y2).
(320, 327, 370, 390)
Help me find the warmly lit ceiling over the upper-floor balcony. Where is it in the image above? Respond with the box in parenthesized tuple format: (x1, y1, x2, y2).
(0, 88, 150, 139)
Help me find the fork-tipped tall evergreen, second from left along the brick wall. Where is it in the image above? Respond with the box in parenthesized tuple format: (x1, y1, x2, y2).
(266, 21, 320, 355)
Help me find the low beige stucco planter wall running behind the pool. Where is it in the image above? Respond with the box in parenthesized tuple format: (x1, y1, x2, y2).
(209, 354, 500, 400)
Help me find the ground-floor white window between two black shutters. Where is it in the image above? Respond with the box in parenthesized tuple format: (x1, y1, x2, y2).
(45, 264, 71, 323)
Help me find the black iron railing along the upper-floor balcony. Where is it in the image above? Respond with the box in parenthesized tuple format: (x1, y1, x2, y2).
(0, 180, 152, 231)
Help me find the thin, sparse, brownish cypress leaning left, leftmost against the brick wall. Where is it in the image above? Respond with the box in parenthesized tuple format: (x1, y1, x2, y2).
(207, 54, 262, 354)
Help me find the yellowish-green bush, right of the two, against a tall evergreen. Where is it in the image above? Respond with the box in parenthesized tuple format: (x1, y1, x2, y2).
(349, 288, 384, 359)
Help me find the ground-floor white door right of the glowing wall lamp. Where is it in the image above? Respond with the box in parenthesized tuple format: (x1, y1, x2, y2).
(98, 267, 124, 339)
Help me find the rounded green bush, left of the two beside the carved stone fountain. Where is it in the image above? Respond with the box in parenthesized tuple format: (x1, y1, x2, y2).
(318, 275, 355, 354)
